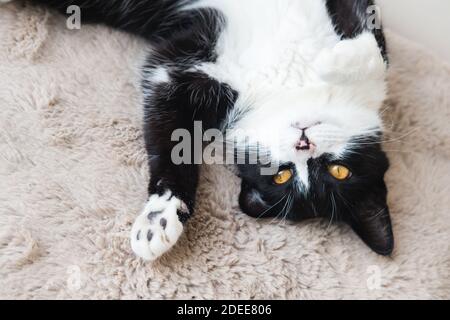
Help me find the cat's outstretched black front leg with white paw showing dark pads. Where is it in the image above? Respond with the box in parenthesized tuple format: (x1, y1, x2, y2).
(131, 58, 237, 260)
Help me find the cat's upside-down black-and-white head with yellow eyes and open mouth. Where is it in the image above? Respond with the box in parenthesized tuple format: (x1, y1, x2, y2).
(232, 86, 393, 255)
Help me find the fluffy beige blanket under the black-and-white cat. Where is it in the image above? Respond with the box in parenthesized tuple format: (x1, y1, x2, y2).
(0, 4, 450, 299)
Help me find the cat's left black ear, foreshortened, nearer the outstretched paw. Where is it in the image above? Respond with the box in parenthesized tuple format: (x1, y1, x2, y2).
(239, 181, 271, 218)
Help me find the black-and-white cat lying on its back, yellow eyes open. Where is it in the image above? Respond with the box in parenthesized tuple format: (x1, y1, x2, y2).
(1, 0, 394, 260)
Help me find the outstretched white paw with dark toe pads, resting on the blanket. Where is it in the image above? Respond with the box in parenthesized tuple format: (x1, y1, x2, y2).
(131, 192, 187, 261)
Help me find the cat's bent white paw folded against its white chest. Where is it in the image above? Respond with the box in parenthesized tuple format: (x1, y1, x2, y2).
(314, 32, 386, 84)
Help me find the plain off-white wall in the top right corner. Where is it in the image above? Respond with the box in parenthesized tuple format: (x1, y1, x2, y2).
(376, 0, 450, 62)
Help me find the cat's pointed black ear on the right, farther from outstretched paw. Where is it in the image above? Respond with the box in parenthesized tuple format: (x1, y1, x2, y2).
(347, 183, 394, 256)
